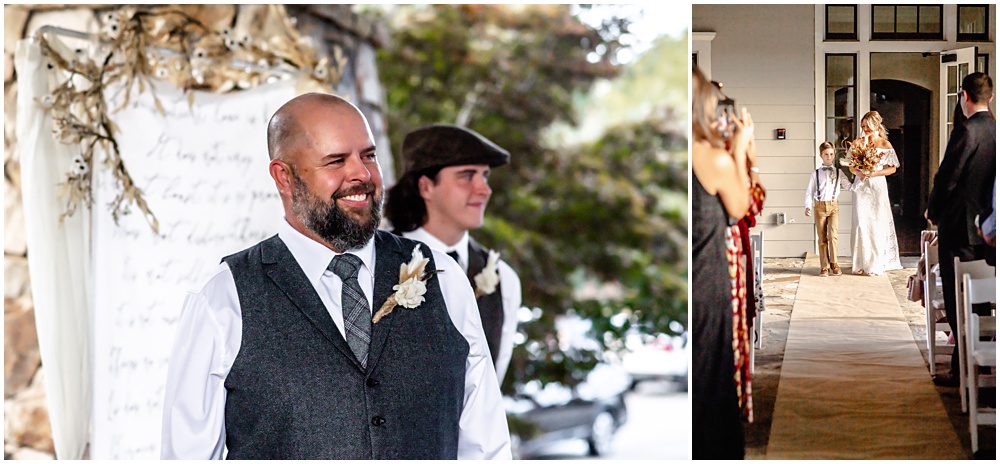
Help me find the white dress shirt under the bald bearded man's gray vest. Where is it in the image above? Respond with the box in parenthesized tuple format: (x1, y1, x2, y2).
(160, 220, 511, 459)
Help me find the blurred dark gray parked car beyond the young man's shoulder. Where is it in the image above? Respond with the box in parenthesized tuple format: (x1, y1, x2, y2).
(504, 315, 632, 459)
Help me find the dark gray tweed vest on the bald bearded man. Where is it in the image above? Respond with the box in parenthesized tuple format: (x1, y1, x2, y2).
(223, 231, 469, 459)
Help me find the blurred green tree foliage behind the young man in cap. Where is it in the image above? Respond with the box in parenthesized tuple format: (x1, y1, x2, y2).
(379, 5, 687, 392)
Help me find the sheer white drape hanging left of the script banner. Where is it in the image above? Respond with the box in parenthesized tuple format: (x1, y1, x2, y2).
(14, 36, 91, 459)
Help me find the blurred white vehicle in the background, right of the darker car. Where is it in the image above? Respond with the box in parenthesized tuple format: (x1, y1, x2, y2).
(622, 334, 690, 391)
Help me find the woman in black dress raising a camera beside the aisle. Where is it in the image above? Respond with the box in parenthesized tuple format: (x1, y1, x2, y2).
(691, 67, 753, 459)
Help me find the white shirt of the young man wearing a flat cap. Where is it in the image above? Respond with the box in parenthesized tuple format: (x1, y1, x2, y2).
(403, 227, 521, 383)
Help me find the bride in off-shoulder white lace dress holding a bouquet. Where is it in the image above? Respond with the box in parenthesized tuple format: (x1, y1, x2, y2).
(851, 111, 903, 275)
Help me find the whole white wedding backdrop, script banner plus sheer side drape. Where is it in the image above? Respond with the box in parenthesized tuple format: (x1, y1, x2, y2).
(16, 34, 298, 459)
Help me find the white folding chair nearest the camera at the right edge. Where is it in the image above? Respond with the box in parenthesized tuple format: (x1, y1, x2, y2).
(960, 274, 997, 453)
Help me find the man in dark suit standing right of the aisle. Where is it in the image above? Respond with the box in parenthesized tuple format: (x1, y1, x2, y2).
(926, 72, 996, 386)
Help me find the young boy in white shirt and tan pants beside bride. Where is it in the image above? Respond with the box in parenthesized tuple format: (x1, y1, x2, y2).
(806, 142, 850, 277)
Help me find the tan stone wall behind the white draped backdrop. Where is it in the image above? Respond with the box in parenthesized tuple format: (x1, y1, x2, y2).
(4, 5, 394, 459)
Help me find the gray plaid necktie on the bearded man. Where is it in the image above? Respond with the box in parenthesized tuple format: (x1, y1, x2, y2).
(327, 253, 372, 367)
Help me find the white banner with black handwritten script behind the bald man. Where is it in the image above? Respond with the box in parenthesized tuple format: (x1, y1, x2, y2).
(91, 71, 295, 459)
